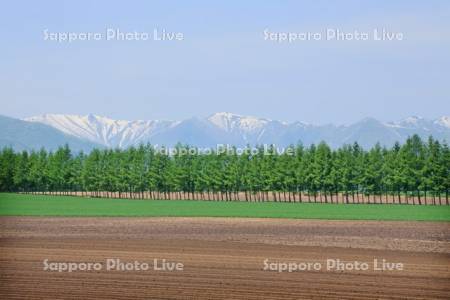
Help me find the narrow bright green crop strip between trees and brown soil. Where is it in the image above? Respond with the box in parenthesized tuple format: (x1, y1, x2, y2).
(0, 193, 450, 221)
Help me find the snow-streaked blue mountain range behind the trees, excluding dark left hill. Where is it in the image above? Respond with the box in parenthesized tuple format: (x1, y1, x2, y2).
(26, 112, 450, 148)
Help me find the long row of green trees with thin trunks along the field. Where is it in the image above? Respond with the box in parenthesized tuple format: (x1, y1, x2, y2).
(0, 135, 450, 205)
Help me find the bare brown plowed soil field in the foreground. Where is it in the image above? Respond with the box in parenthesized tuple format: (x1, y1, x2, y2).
(0, 217, 450, 299)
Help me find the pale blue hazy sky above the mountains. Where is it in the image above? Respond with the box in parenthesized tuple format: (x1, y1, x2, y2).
(0, 0, 450, 124)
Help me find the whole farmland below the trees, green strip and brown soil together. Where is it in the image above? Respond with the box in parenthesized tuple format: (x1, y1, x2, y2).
(0, 193, 450, 299)
